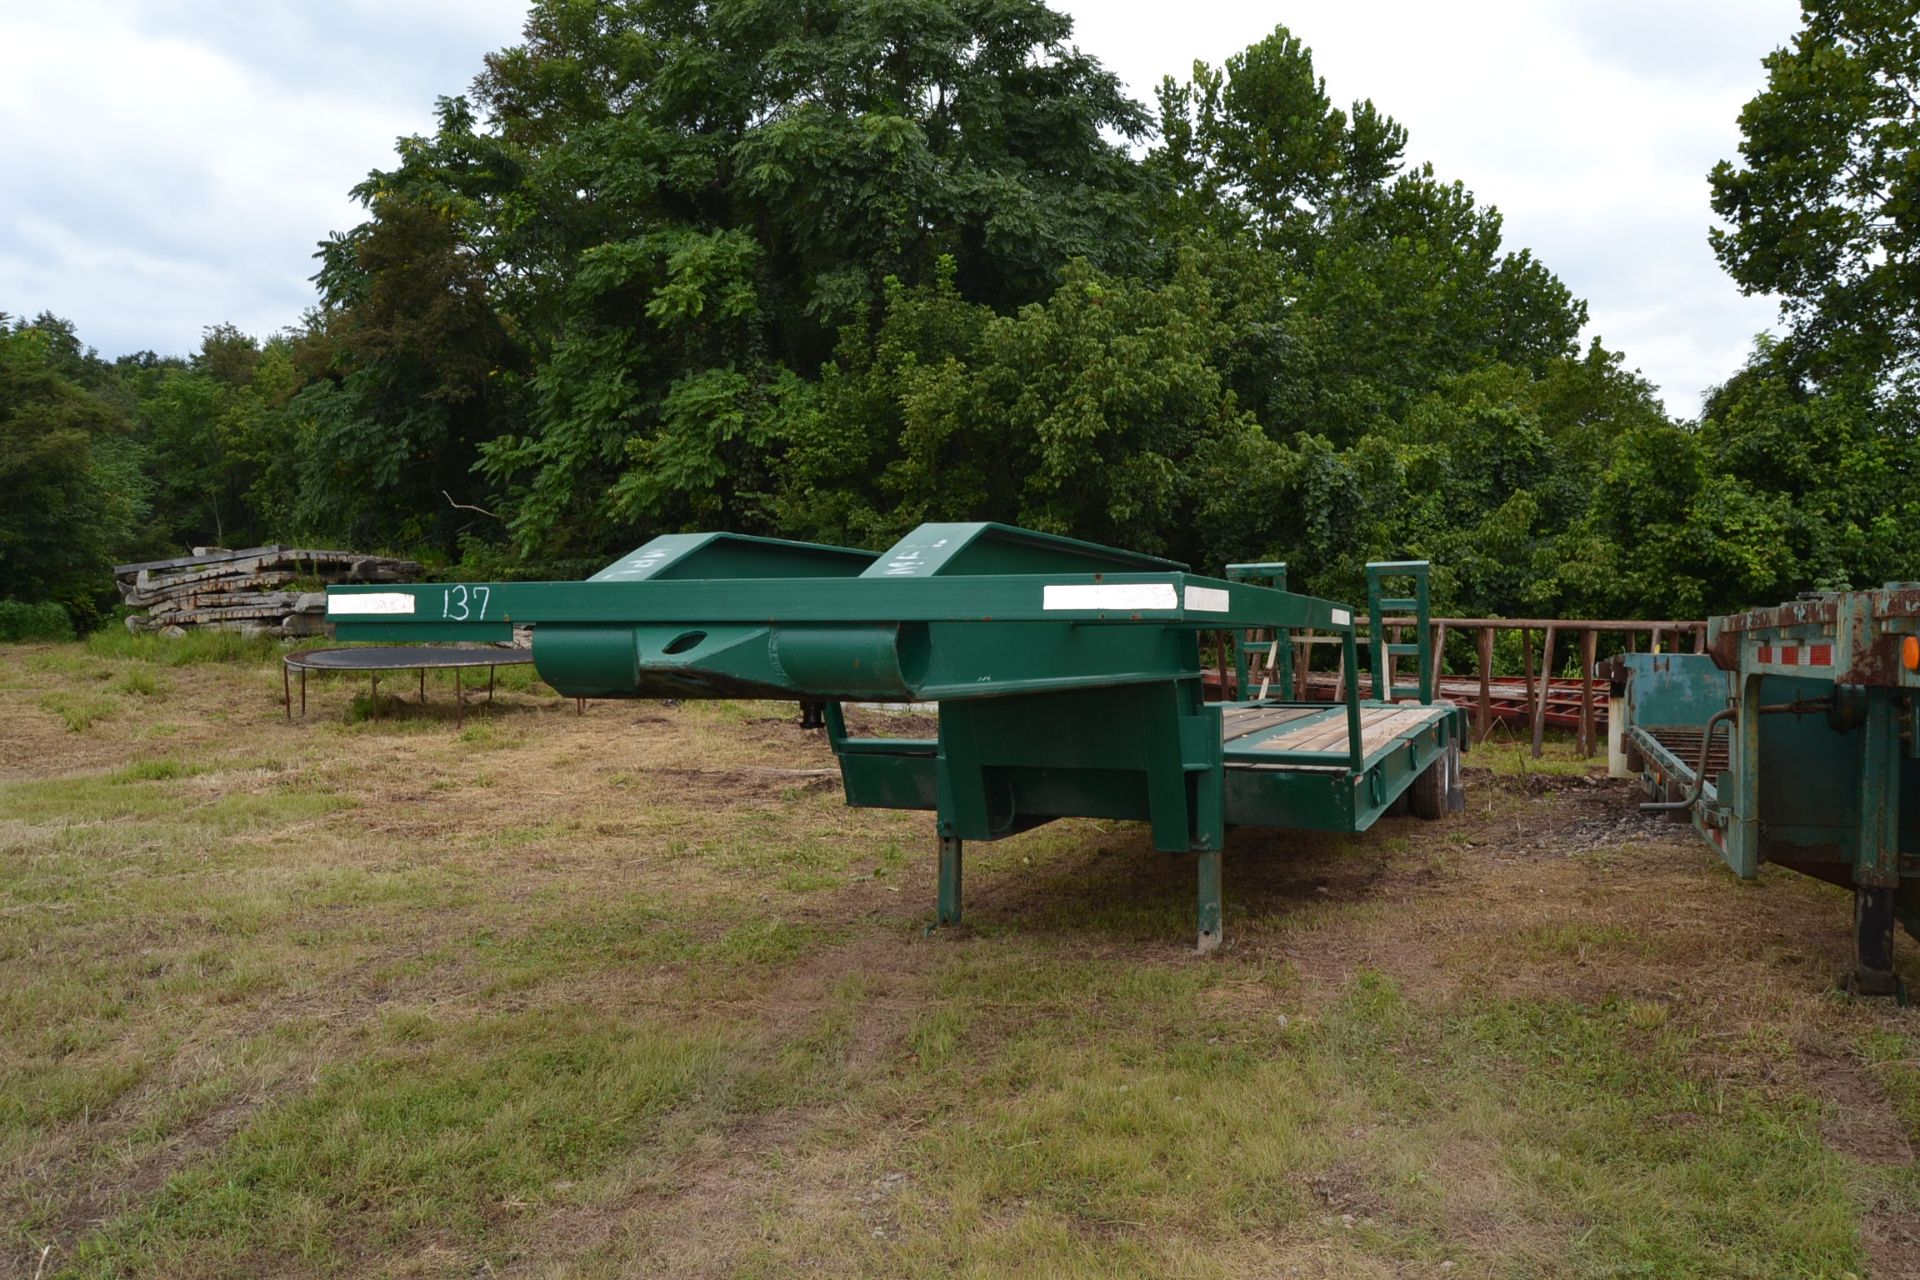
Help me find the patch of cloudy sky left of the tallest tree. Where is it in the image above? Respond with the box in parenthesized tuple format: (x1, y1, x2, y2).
(0, 0, 526, 355)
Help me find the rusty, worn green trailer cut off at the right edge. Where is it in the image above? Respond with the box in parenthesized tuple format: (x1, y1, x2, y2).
(1613, 585, 1920, 994)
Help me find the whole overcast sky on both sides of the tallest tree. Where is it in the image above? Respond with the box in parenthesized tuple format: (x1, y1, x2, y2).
(0, 0, 1797, 416)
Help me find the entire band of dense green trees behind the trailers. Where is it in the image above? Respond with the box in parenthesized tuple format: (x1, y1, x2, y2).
(0, 0, 1920, 633)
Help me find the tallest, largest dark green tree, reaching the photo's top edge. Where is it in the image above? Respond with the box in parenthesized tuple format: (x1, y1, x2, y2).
(309, 0, 1144, 553)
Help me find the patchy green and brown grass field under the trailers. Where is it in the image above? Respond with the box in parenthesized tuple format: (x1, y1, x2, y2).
(0, 637, 1920, 1278)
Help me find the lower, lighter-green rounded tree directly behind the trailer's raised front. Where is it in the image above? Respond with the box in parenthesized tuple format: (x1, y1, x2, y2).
(780, 261, 1260, 558)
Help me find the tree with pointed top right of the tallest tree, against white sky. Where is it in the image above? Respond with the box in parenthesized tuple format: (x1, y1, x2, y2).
(1146, 27, 1586, 445)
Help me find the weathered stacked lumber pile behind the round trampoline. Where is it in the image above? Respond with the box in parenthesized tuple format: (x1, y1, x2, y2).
(113, 547, 420, 637)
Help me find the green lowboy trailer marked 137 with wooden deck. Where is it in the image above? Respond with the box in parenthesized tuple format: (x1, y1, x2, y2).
(326, 524, 1467, 950)
